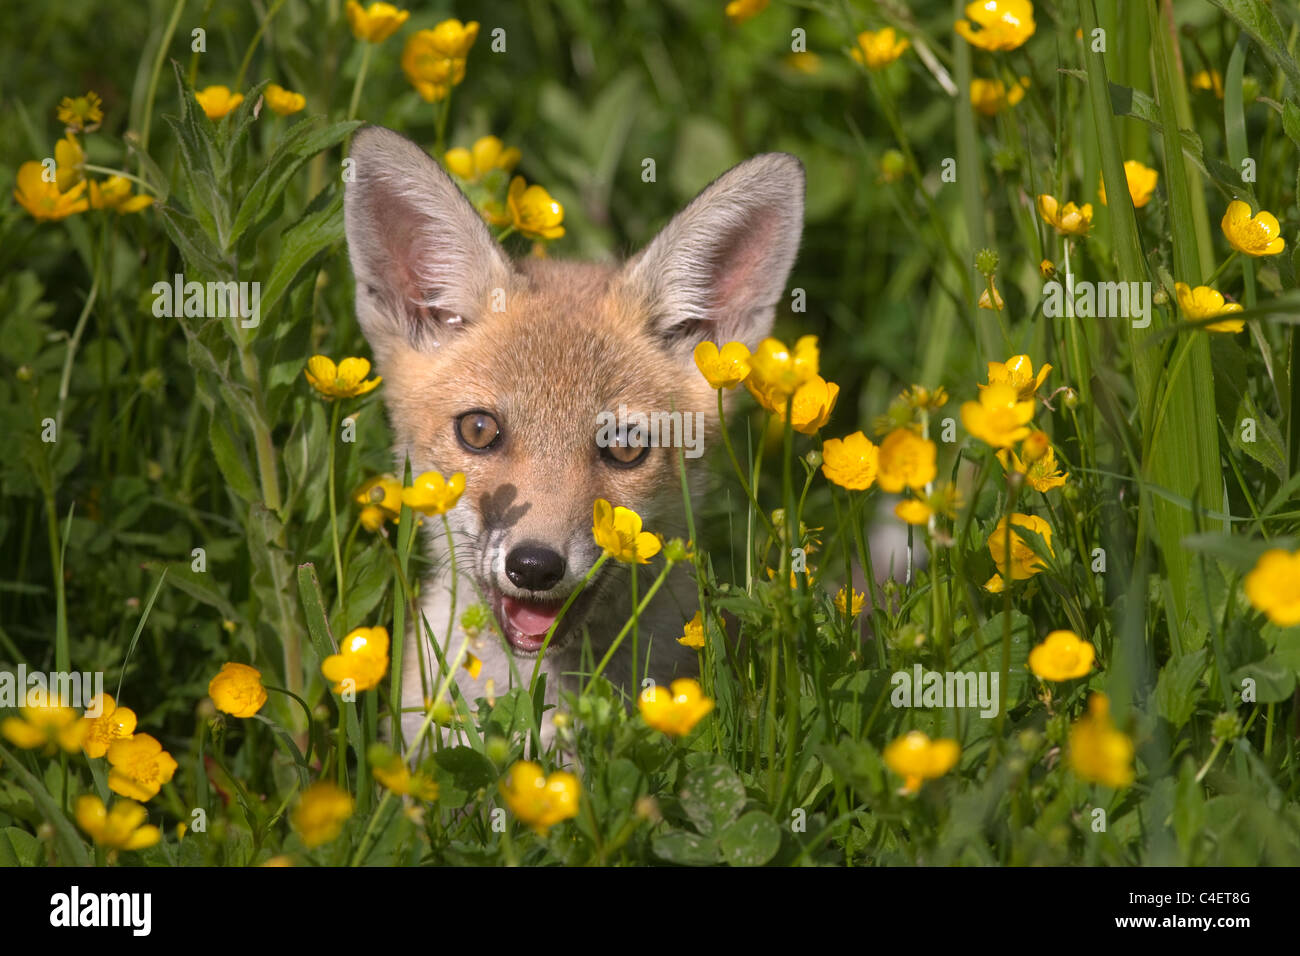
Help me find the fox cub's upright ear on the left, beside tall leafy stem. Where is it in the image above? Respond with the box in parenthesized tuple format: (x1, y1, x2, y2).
(343, 126, 510, 358)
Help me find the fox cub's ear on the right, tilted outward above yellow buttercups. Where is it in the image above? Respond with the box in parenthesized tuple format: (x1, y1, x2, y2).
(624, 152, 803, 349)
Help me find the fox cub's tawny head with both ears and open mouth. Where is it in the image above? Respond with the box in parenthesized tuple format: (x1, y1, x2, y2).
(345, 127, 803, 654)
